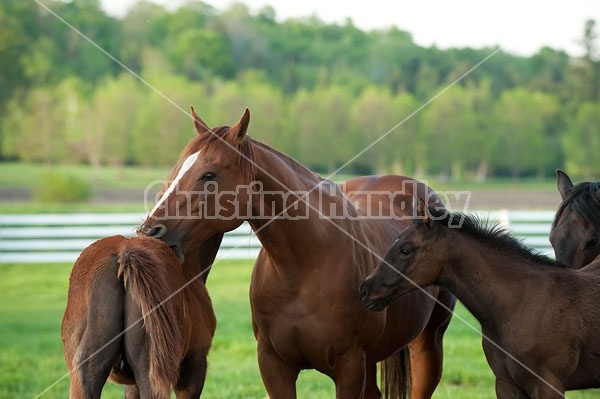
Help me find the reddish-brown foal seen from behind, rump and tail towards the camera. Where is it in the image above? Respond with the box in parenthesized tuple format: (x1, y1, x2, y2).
(61, 236, 216, 399)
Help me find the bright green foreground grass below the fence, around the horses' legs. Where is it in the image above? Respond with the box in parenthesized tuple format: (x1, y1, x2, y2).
(0, 261, 600, 399)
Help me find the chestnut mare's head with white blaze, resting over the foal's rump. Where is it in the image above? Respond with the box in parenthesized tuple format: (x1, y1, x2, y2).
(138, 107, 254, 254)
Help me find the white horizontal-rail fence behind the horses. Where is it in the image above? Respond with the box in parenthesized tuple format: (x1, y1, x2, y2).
(0, 210, 554, 263)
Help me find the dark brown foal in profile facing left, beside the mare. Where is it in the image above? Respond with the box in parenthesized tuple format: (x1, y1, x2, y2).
(361, 202, 600, 399)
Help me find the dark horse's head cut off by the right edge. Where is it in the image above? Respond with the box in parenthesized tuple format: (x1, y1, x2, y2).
(550, 169, 600, 269)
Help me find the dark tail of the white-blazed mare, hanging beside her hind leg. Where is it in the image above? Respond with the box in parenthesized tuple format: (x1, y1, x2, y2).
(380, 346, 412, 399)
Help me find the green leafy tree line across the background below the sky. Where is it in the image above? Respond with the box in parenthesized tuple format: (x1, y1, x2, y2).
(0, 0, 600, 180)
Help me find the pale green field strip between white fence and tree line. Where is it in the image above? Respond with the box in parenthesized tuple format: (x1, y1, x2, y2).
(0, 162, 564, 213)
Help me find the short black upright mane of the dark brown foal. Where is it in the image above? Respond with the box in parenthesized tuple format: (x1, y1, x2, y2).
(429, 207, 558, 266)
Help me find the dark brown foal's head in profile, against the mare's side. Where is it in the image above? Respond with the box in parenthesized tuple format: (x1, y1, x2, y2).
(360, 216, 440, 310)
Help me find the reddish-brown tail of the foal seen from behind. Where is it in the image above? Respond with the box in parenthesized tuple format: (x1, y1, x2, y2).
(118, 239, 183, 398)
